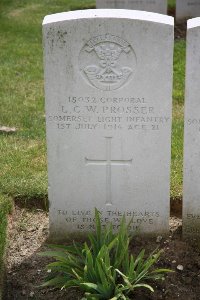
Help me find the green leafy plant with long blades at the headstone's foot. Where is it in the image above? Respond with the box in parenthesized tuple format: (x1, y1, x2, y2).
(40, 209, 170, 300)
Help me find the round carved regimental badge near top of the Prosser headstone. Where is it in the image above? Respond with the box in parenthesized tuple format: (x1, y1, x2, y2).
(79, 34, 136, 91)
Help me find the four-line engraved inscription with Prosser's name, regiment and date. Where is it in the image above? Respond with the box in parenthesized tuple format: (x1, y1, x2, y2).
(47, 95, 170, 132)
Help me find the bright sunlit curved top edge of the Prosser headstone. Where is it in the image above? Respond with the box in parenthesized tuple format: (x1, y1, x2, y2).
(42, 9, 174, 26)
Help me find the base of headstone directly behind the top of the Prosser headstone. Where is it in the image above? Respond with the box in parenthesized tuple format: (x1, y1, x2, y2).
(96, 0, 167, 14)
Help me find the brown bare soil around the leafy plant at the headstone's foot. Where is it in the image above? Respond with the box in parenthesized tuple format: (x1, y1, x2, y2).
(4, 206, 200, 300)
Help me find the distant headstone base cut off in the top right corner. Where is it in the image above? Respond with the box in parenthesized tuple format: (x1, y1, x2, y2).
(176, 0, 200, 21)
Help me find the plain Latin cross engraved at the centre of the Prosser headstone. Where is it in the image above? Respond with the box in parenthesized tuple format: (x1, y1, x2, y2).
(85, 137, 133, 205)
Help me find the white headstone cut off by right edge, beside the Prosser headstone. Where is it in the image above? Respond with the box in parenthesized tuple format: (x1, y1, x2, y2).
(183, 18, 200, 236)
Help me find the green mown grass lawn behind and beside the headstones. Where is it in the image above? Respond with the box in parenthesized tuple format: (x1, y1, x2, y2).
(0, 0, 185, 286)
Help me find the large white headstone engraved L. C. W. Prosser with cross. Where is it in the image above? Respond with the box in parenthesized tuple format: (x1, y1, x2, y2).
(43, 10, 173, 239)
